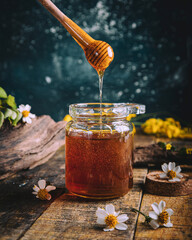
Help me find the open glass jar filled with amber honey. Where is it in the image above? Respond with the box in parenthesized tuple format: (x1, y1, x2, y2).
(65, 103, 145, 199)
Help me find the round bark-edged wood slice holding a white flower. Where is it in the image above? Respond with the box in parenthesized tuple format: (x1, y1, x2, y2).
(145, 171, 192, 197)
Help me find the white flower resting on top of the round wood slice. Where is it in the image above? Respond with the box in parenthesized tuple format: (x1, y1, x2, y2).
(159, 162, 183, 182)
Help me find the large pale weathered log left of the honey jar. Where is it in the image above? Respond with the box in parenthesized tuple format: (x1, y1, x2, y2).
(0, 115, 66, 179)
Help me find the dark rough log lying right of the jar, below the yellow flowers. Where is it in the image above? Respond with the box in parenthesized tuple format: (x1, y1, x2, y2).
(134, 142, 192, 167)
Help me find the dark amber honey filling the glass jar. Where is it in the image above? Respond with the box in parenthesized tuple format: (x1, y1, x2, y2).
(66, 132, 133, 199)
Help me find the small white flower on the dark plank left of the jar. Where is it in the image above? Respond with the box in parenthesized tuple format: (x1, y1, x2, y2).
(32, 179, 56, 200)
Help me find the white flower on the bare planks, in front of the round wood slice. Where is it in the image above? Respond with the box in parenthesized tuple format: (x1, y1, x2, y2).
(149, 201, 173, 229)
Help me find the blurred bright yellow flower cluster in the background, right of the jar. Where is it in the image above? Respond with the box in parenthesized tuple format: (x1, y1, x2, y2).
(141, 118, 192, 138)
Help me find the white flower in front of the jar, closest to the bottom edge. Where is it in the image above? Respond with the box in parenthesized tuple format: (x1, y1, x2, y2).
(96, 204, 129, 231)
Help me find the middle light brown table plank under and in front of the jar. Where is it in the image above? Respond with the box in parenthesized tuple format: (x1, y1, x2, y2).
(22, 169, 147, 240)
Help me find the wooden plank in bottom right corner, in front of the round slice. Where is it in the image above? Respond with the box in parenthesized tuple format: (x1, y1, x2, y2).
(135, 172, 192, 240)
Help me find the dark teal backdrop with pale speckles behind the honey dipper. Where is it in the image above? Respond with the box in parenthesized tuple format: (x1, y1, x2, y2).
(0, 0, 192, 122)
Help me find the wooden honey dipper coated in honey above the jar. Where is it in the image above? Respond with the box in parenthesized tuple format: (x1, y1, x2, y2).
(38, 0, 114, 75)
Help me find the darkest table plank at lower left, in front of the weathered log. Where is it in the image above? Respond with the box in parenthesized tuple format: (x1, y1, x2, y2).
(0, 149, 65, 240)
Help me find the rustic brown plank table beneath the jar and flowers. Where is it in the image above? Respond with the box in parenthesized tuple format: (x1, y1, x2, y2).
(0, 134, 192, 240)
